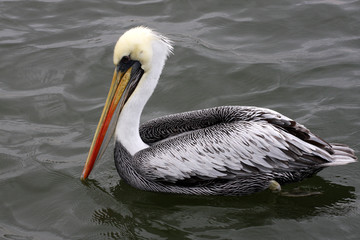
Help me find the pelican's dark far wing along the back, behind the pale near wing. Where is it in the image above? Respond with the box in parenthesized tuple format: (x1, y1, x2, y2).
(140, 106, 333, 153)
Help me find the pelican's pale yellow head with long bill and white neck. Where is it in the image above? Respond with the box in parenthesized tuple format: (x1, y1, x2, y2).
(81, 27, 173, 180)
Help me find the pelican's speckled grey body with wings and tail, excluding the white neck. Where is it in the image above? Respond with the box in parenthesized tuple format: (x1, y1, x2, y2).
(115, 106, 356, 195)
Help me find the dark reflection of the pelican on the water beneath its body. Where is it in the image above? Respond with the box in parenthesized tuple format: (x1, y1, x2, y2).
(90, 176, 356, 239)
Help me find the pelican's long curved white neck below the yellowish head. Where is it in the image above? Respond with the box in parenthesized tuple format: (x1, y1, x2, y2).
(115, 41, 169, 156)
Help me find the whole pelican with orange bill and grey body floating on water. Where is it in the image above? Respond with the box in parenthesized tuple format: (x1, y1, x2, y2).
(81, 27, 357, 195)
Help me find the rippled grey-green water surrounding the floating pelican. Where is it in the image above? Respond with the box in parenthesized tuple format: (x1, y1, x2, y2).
(0, 0, 360, 239)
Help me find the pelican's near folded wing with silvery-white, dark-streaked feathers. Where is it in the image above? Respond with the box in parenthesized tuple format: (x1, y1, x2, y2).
(135, 122, 327, 182)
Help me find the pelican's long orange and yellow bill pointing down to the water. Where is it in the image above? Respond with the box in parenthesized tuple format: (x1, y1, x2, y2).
(81, 63, 142, 180)
